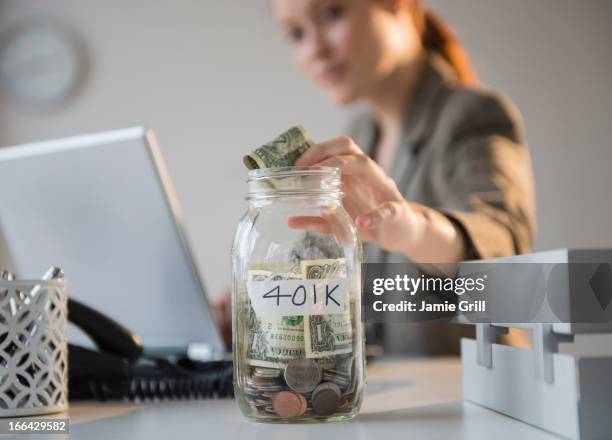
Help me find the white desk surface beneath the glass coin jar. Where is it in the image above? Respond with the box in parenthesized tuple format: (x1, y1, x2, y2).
(18, 358, 558, 440)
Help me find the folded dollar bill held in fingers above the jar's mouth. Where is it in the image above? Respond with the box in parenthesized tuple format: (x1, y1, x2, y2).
(242, 125, 314, 170)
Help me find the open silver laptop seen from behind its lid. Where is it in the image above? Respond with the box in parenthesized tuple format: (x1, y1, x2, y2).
(0, 127, 225, 360)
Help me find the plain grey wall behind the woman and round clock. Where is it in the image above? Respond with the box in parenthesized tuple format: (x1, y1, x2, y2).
(0, 0, 612, 295)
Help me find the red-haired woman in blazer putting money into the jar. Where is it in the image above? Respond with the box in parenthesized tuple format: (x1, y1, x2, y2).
(218, 0, 534, 353)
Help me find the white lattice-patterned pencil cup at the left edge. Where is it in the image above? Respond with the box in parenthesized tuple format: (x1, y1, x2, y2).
(0, 279, 68, 417)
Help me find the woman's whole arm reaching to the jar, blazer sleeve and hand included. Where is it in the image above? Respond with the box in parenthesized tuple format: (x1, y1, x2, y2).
(292, 95, 535, 263)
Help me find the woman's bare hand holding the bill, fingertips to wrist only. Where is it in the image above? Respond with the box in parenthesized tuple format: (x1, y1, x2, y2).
(289, 136, 422, 253)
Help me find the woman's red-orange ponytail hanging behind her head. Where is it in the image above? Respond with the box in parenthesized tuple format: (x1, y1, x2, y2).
(412, 0, 478, 85)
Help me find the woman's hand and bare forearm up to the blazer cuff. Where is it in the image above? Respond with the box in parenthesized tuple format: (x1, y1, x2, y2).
(289, 136, 466, 263)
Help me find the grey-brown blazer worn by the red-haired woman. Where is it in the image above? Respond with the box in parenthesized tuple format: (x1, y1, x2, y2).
(349, 58, 535, 354)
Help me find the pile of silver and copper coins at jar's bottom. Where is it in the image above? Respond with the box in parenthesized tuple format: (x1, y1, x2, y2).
(244, 359, 354, 418)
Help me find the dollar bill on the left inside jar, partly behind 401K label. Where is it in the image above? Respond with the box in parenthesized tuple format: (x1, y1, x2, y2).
(244, 268, 305, 369)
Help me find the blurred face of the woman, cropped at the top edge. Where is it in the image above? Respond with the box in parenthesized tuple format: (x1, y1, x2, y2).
(272, 0, 417, 104)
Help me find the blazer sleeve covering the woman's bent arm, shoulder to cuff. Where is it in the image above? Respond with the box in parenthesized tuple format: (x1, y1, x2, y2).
(436, 89, 536, 259)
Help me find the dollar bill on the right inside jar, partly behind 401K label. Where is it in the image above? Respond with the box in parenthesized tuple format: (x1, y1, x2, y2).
(300, 258, 353, 358)
